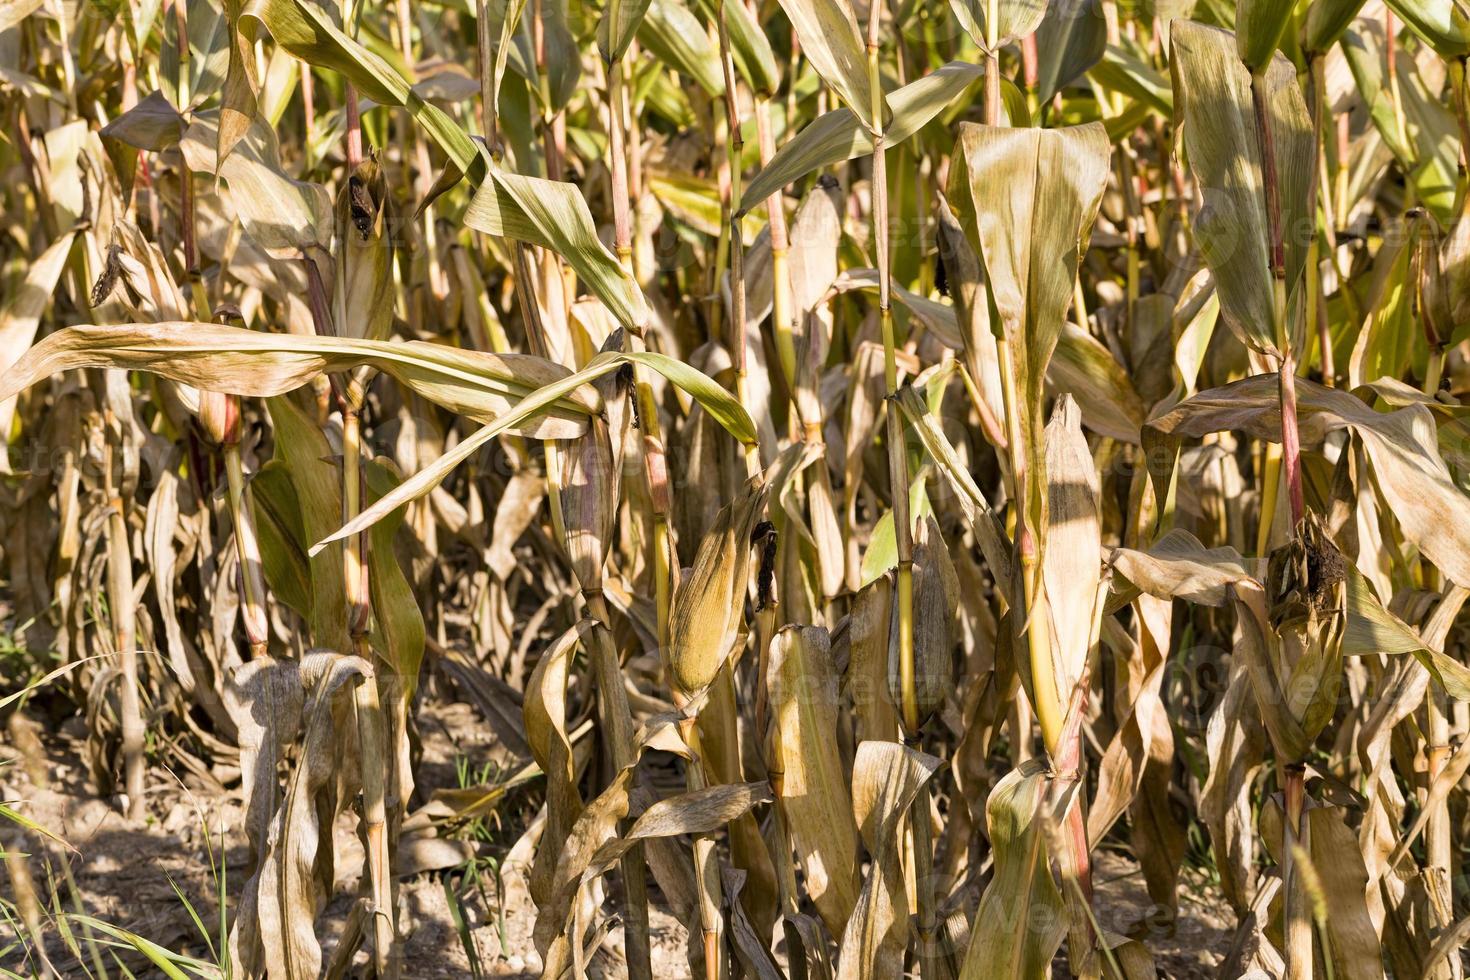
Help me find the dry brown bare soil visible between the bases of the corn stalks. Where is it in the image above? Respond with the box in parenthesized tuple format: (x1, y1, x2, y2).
(0, 681, 1230, 980)
